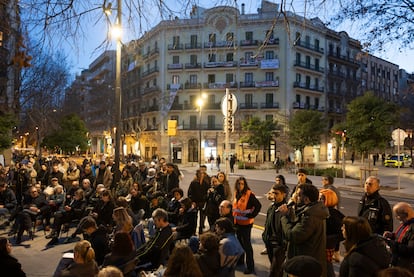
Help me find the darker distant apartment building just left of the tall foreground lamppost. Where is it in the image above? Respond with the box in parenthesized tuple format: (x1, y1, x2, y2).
(65, 50, 115, 157)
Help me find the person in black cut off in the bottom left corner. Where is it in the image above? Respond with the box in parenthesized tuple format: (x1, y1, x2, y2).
(0, 237, 26, 277)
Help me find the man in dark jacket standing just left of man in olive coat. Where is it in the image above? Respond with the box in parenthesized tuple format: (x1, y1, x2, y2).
(262, 184, 288, 277)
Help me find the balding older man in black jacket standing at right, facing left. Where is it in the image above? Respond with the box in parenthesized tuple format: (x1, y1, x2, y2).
(358, 176, 393, 236)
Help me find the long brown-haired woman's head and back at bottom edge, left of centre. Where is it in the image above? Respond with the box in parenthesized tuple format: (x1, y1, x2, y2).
(164, 244, 203, 277)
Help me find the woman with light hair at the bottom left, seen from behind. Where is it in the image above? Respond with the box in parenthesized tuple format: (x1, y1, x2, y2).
(58, 240, 99, 277)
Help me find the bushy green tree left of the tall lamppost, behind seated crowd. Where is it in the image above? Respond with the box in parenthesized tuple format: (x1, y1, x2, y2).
(42, 114, 88, 153)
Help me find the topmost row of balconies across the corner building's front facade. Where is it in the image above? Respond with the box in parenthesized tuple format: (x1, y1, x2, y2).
(168, 38, 279, 50)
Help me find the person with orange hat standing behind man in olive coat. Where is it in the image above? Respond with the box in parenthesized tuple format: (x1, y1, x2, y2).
(319, 189, 345, 277)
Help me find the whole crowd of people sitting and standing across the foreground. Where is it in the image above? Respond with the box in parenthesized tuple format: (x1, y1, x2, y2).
(0, 157, 414, 277)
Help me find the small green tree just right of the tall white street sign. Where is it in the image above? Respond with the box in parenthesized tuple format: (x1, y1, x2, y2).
(240, 117, 280, 161)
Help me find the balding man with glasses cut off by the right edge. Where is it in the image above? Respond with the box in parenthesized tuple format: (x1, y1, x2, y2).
(384, 202, 414, 274)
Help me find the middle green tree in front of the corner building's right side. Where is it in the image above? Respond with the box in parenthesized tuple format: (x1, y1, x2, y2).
(289, 110, 326, 162)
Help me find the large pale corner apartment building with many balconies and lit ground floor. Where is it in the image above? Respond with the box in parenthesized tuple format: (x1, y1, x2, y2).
(122, 1, 362, 163)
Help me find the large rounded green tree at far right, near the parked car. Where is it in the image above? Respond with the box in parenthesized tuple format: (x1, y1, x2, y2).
(346, 92, 399, 158)
